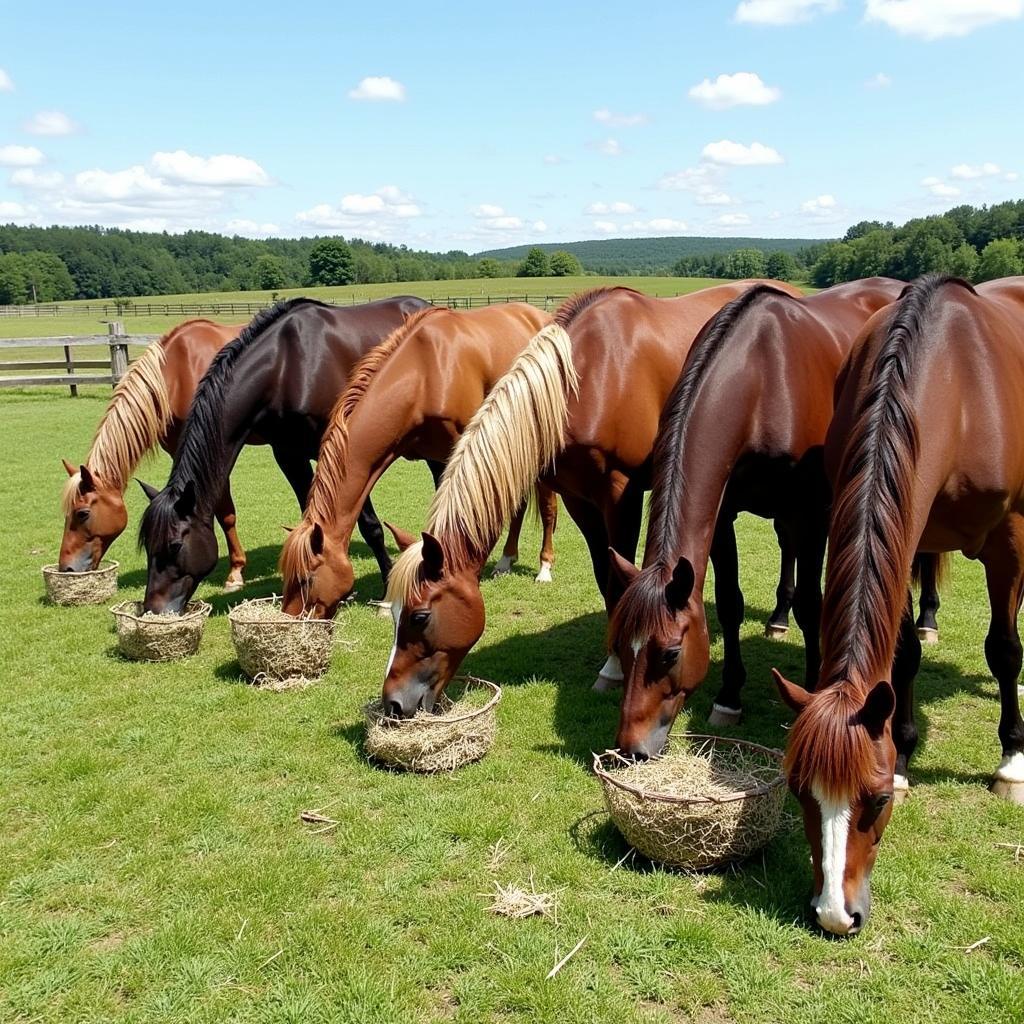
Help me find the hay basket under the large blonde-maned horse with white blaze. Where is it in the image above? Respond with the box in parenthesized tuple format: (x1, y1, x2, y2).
(365, 676, 502, 773)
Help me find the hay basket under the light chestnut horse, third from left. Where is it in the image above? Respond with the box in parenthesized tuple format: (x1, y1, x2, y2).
(227, 597, 335, 689)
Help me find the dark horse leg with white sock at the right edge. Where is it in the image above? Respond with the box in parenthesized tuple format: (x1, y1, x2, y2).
(980, 514, 1024, 804)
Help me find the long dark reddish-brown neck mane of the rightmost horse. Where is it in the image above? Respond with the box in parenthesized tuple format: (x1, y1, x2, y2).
(821, 274, 976, 685)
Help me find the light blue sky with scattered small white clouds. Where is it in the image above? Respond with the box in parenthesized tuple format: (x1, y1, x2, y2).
(0, 0, 1024, 252)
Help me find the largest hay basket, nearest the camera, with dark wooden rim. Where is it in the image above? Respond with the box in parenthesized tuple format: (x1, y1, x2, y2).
(594, 733, 786, 870)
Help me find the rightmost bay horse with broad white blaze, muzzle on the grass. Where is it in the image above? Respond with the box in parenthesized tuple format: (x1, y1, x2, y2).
(774, 275, 1024, 935)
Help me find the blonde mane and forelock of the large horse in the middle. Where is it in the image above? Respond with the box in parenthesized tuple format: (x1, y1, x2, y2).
(387, 324, 580, 603)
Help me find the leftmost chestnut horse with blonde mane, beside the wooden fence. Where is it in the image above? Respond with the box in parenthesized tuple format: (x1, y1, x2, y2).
(59, 319, 246, 591)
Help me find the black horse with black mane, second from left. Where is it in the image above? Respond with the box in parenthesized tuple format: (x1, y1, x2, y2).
(139, 296, 427, 612)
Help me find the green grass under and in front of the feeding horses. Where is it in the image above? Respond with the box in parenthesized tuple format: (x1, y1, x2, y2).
(0, 389, 1024, 1024)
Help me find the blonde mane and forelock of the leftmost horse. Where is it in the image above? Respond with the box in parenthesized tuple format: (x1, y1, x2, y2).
(60, 339, 171, 516)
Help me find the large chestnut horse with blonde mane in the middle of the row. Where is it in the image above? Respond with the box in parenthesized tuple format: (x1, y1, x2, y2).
(383, 282, 800, 716)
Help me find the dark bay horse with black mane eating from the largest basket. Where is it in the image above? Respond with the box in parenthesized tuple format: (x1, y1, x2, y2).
(608, 278, 904, 757)
